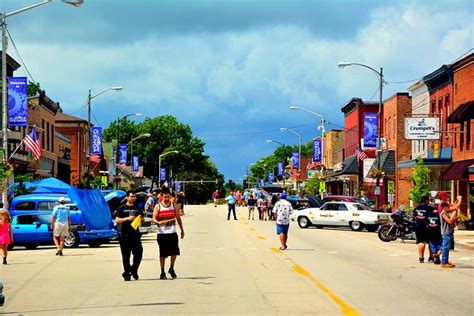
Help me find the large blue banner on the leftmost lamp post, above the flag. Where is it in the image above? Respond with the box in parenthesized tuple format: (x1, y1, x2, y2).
(8, 77, 28, 126)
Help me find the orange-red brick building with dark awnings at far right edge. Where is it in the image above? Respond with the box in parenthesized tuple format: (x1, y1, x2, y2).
(442, 53, 474, 212)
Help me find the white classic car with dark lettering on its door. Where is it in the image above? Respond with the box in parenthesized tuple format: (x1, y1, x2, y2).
(290, 202, 389, 232)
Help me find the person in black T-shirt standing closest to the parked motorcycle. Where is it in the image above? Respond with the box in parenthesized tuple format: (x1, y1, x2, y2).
(413, 195, 434, 263)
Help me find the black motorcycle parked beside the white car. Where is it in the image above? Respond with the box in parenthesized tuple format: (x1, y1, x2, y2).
(378, 210, 416, 242)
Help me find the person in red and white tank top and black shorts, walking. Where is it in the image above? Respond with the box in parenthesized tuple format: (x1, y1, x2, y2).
(153, 188, 184, 280)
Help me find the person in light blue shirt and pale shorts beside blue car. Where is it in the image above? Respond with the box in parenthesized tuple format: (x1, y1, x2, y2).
(51, 197, 71, 256)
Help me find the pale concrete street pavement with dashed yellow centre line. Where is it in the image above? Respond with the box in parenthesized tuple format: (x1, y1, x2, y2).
(0, 206, 474, 315)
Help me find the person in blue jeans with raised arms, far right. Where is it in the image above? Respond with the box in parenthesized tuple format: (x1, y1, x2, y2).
(440, 196, 462, 268)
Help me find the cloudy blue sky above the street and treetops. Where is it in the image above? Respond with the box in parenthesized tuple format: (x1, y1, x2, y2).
(0, 0, 474, 181)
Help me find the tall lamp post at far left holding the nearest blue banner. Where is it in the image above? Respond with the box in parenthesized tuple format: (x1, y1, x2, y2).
(1, 0, 84, 202)
